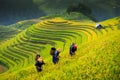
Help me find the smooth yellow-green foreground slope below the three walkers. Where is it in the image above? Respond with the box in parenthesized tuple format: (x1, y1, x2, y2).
(17, 31, 120, 80)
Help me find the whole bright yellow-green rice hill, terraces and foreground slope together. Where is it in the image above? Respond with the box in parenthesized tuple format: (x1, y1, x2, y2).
(0, 17, 120, 80)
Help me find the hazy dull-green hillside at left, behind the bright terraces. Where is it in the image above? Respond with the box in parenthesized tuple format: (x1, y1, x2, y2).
(0, 19, 40, 43)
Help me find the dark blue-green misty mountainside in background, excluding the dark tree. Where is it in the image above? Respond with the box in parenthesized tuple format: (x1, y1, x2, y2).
(0, 0, 120, 25)
